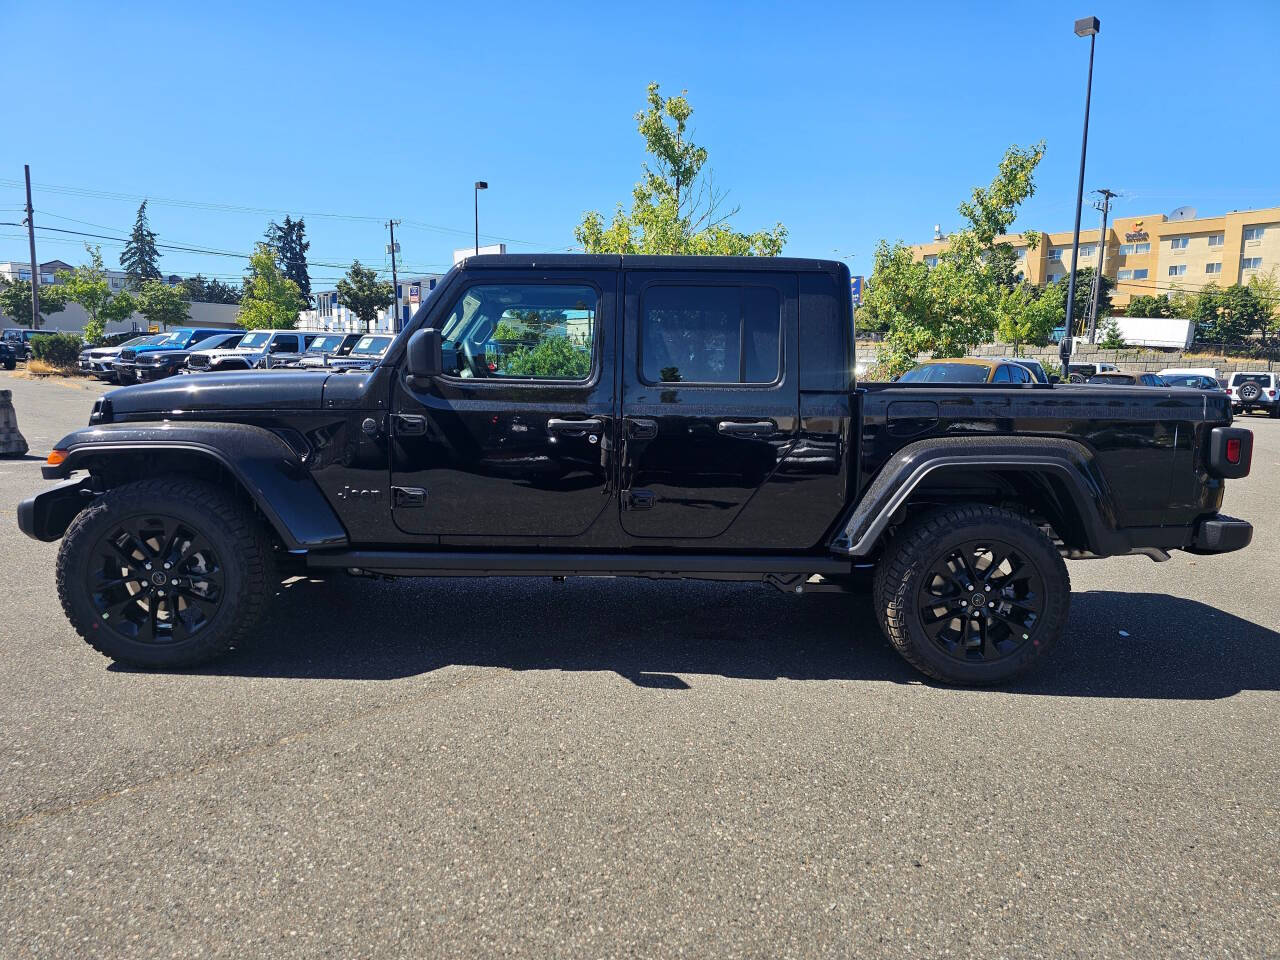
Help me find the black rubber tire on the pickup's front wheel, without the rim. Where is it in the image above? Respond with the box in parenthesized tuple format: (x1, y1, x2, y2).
(58, 476, 275, 669)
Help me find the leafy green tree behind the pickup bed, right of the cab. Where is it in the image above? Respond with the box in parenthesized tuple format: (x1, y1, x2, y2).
(859, 142, 1044, 376)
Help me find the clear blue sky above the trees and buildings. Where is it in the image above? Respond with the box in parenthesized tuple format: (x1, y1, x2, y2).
(0, 0, 1280, 288)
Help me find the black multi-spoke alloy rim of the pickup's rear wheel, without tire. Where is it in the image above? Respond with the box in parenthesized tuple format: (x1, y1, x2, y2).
(916, 540, 1044, 663)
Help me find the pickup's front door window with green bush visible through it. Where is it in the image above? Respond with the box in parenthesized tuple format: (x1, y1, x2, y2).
(442, 283, 596, 380)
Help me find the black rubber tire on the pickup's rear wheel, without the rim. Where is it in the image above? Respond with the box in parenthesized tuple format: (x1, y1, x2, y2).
(872, 504, 1071, 686)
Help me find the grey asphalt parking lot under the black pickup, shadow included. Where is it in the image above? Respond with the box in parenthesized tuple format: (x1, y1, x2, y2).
(0, 374, 1280, 957)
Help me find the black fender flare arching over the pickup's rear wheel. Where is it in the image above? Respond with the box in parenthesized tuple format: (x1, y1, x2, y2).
(829, 436, 1130, 557)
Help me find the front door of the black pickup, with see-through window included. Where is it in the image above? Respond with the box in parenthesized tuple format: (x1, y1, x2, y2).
(390, 270, 617, 547)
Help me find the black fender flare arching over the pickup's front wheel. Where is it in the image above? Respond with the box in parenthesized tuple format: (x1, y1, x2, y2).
(28, 421, 349, 552)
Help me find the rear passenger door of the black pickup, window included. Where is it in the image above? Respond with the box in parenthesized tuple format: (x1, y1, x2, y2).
(620, 270, 799, 548)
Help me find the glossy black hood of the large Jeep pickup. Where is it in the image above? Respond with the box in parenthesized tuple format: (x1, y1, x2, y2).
(106, 370, 332, 417)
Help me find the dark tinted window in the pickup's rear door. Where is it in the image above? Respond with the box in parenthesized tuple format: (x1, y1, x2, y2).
(640, 284, 782, 383)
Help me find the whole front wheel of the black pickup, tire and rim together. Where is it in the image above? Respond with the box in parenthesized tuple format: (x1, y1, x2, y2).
(58, 476, 274, 668)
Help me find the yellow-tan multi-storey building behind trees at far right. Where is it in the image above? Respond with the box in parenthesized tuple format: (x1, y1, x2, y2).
(911, 207, 1280, 308)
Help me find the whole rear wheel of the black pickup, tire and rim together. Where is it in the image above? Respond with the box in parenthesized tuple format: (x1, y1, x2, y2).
(874, 504, 1071, 685)
